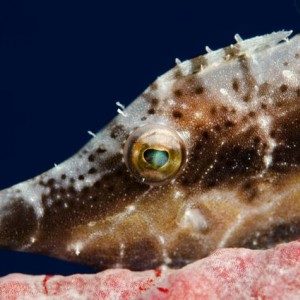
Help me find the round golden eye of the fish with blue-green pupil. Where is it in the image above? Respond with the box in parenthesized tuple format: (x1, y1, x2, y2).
(124, 124, 186, 185)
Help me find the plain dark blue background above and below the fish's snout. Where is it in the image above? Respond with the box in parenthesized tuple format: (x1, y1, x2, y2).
(0, 0, 300, 275)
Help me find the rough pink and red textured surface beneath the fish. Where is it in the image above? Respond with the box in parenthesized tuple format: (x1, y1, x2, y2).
(0, 241, 300, 300)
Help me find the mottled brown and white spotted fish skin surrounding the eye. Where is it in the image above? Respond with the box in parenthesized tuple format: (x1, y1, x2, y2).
(0, 31, 300, 270)
